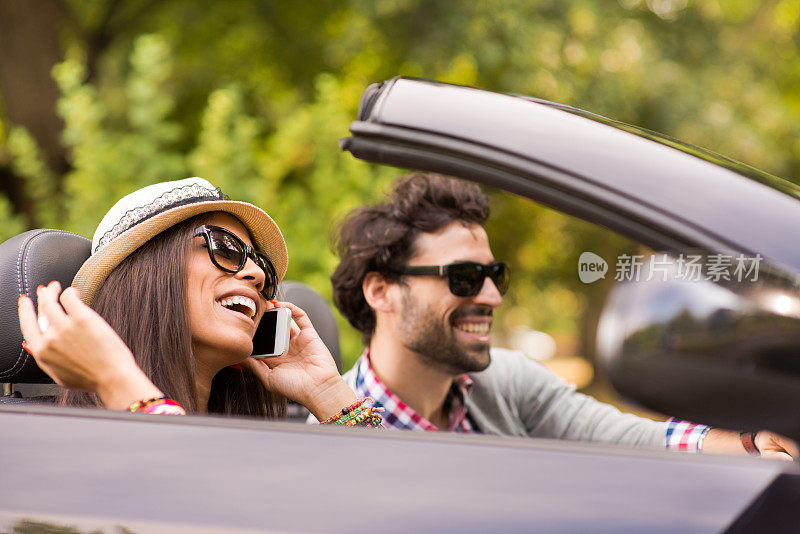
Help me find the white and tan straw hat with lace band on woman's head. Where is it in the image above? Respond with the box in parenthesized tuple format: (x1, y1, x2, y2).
(72, 178, 289, 305)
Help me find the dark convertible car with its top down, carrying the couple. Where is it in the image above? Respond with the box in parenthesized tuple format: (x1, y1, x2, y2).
(0, 78, 800, 533)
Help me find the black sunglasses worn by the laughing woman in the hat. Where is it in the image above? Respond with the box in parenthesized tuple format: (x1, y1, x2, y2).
(194, 224, 278, 300)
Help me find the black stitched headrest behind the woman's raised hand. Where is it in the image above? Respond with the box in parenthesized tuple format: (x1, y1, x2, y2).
(0, 229, 91, 384)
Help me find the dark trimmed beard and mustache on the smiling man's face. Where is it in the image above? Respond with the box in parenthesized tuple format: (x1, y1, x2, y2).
(400, 293, 492, 375)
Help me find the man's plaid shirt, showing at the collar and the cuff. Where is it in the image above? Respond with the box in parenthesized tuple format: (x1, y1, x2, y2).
(354, 349, 711, 452)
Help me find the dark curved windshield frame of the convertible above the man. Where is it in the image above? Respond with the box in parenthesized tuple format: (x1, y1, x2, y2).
(341, 78, 800, 278)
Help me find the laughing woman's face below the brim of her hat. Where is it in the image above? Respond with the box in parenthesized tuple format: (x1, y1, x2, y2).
(186, 213, 272, 370)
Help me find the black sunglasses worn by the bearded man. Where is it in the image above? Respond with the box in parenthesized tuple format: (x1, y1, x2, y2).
(400, 261, 508, 297)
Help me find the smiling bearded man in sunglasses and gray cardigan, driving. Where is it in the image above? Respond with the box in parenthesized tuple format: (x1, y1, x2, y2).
(331, 174, 797, 459)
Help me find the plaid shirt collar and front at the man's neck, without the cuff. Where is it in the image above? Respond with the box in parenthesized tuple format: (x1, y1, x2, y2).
(354, 349, 480, 434)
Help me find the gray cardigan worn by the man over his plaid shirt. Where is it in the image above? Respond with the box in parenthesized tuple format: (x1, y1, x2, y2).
(336, 348, 666, 448)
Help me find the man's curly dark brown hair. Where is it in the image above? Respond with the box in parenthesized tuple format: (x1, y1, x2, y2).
(331, 173, 489, 343)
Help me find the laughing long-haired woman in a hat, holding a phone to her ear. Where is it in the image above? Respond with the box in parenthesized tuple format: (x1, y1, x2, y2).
(19, 178, 380, 426)
